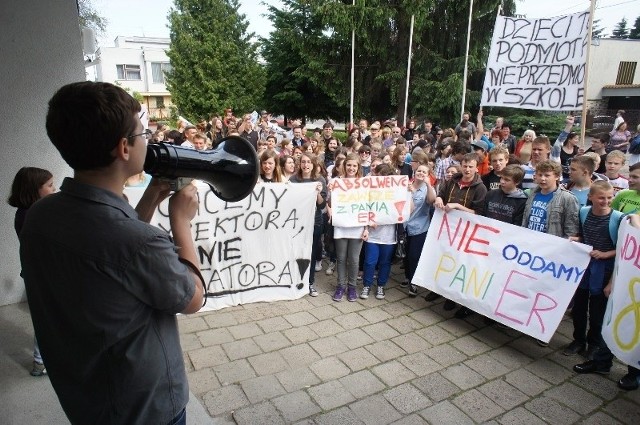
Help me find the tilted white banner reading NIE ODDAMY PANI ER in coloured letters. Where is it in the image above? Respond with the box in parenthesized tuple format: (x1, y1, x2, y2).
(412, 210, 591, 342)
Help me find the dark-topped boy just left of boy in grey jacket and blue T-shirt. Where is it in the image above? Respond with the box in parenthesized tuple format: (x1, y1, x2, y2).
(483, 165, 527, 226)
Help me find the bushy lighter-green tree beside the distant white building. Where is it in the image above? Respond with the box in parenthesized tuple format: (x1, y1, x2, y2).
(166, 0, 265, 121)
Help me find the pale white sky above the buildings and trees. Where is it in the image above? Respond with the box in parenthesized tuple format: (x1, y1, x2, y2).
(93, 0, 640, 47)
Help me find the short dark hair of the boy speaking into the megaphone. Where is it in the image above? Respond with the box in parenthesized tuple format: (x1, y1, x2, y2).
(46, 81, 140, 170)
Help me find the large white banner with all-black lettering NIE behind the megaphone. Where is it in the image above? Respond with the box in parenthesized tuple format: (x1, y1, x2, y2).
(125, 183, 316, 311)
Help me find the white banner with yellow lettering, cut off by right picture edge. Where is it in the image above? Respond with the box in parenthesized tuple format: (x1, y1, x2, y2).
(602, 220, 640, 368)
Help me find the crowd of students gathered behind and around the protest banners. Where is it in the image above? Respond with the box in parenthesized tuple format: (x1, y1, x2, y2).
(12, 105, 640, 389)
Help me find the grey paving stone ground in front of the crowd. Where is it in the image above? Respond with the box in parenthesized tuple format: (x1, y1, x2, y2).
(178, 263, 640, 425)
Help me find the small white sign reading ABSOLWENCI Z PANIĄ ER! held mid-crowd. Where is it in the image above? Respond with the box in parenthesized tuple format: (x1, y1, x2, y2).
(329, 176, 411, 227)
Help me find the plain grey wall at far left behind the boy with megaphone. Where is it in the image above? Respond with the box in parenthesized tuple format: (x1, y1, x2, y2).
(0, 0, 85, 304)
